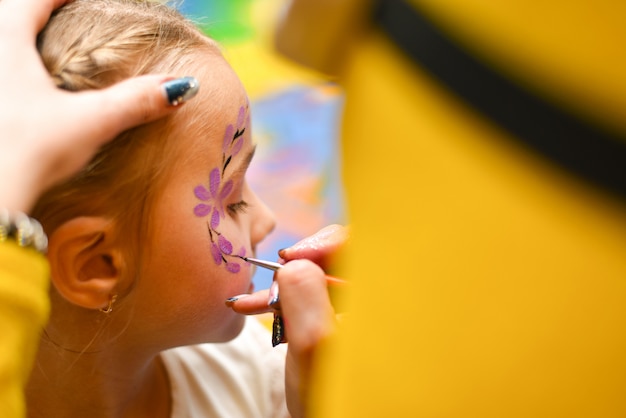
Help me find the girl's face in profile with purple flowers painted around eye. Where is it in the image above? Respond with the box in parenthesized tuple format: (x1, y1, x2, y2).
(126, 52, 274, 345)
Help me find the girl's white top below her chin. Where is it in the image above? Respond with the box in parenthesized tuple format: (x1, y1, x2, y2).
(161, 317, 289, 418)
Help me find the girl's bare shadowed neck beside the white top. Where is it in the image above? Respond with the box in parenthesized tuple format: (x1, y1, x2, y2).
(26, 322, 171, 418)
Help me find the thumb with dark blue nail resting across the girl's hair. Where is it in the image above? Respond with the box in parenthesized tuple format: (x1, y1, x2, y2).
(75, 75, 199, 147)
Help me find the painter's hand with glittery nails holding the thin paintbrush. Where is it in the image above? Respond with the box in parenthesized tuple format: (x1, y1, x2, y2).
(227, 225, 348, 416)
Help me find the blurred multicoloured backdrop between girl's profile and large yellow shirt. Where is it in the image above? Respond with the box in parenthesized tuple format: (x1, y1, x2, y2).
(178, 0, 346, 289)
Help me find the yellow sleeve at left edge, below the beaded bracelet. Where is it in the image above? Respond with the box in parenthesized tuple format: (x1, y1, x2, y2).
(0, 242, 50, 418)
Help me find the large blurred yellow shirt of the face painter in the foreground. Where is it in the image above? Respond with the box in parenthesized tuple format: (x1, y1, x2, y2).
(279, 0, 626, 418)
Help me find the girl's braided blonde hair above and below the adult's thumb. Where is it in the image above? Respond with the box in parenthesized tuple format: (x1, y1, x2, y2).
(32, 0, 220, 274)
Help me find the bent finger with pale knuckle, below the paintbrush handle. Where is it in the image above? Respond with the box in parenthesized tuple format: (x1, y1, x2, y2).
(276, 260, 334, 352)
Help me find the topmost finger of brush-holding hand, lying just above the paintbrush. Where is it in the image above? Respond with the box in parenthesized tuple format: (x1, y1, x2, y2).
(278, 224, 349, 266)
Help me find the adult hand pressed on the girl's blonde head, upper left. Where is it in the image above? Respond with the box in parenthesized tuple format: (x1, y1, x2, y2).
(0, 0, 197, 211)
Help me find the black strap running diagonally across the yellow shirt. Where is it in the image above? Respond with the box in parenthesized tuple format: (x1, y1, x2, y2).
(375, 0, 626, 202)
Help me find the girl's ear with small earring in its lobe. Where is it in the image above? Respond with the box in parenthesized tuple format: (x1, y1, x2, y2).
(48, 217, 124, 309)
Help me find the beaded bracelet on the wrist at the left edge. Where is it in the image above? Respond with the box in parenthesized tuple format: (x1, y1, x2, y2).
(0, 209, 48, 254)
